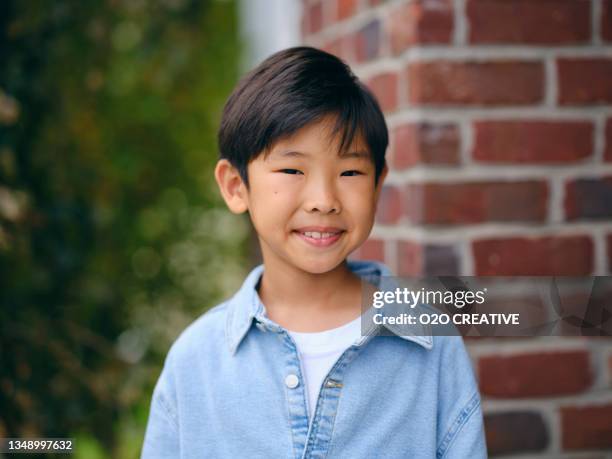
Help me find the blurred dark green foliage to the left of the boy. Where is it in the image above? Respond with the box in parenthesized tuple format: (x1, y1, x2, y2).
(0, 0, 248, 457)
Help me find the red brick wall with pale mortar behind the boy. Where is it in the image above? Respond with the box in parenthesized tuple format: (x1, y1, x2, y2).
(302, 0, 612, 459)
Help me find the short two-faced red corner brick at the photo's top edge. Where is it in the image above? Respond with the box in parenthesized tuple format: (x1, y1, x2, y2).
(387, 0, 453, 54)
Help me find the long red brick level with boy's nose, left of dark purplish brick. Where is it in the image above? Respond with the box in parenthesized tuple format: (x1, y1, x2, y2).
(406, 180, 548, 225)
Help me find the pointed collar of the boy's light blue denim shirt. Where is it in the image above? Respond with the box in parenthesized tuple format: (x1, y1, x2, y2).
(225, 260, 433, 355)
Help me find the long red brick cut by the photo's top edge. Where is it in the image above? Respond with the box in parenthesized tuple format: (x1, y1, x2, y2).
(467, 0, 591, 44)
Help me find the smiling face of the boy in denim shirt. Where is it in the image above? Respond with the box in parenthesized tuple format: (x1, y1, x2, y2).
(217, 117, 387, 274)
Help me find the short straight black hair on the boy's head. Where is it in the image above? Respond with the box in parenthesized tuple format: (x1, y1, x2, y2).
(218, 46, 389, 188)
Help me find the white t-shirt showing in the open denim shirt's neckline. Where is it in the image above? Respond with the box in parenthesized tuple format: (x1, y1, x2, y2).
(288, 316, 361, 420)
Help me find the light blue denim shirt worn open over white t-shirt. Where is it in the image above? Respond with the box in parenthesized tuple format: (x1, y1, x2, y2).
(142, 260, 487, 459)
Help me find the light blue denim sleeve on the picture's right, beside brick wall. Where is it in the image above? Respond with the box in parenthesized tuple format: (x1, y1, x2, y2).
(436, 336, 487, 459)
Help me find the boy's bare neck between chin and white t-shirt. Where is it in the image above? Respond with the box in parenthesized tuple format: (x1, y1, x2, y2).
(258, 260, 361, 332)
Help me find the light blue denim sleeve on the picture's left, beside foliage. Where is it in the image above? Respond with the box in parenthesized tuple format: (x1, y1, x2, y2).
(141, 361, 180, 459)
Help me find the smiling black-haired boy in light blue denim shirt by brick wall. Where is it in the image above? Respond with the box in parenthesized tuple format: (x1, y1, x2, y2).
(142, 47, 486, 458)
